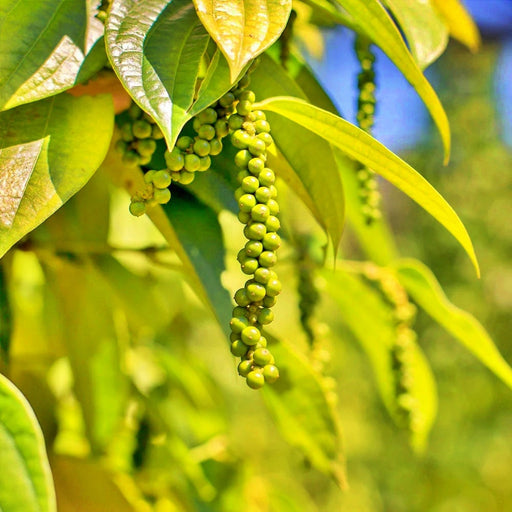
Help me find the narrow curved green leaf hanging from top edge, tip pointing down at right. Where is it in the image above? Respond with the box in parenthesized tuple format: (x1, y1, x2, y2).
(336, 0, 450, 162)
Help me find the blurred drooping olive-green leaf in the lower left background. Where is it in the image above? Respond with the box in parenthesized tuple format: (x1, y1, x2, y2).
(46, 260, 129, 453)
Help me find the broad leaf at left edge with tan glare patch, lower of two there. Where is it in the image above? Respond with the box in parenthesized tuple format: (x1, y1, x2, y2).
(0, 94, 114, 256)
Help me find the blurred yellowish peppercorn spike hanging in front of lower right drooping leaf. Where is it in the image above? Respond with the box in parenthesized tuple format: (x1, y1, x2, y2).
(364, 264, 419, 431)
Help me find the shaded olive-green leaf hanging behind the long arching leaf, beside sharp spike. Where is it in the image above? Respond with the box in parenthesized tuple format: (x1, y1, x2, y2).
(251, 55, 345, 248)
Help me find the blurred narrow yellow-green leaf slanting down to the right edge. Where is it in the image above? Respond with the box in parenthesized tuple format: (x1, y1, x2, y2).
(394, 259, 512, 388)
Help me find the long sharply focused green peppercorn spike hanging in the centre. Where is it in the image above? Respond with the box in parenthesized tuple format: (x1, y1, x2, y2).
(229, 69, 282, 389)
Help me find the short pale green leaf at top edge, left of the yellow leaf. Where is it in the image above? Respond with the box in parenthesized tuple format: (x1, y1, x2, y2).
(384, 0, 448, 69)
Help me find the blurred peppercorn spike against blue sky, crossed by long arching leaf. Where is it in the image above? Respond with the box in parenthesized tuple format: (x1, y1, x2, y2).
(355, 35, 381, 224)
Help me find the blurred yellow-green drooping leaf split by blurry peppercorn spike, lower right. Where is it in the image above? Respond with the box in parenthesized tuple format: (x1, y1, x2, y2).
(322, 264, 437, 451)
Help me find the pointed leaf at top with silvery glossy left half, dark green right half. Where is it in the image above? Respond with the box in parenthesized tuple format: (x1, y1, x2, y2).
(105, 0, 231, 147)
